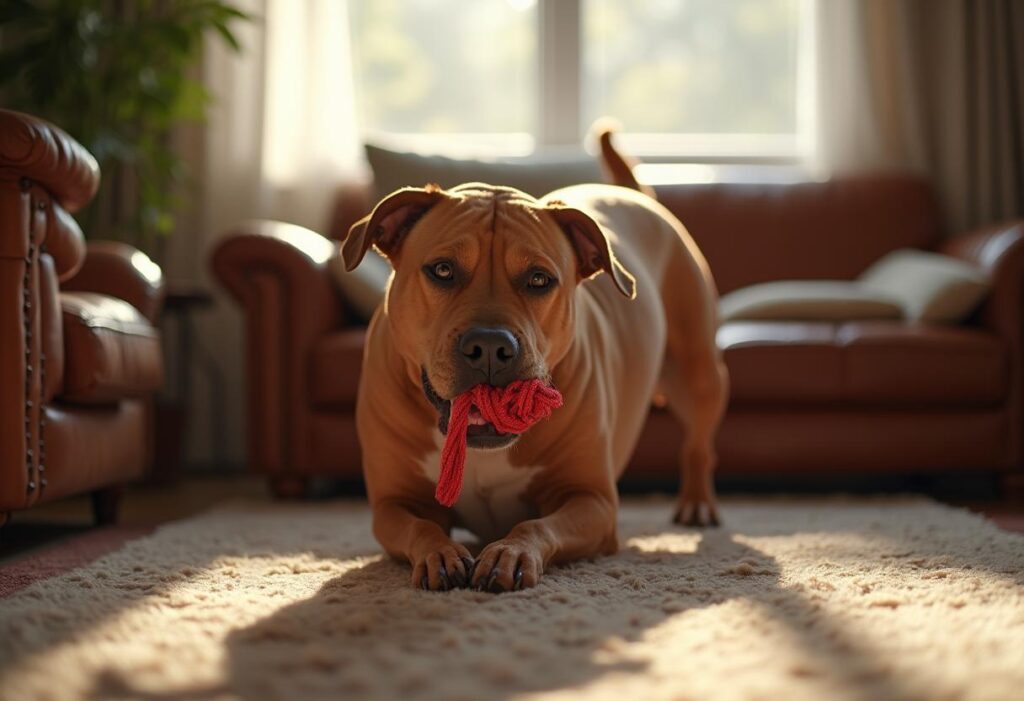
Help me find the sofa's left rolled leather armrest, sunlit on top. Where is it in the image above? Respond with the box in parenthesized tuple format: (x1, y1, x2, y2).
(211, 221, 345, 475)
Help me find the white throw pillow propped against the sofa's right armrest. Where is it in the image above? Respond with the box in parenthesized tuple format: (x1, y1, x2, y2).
(859, 249, 988, 323)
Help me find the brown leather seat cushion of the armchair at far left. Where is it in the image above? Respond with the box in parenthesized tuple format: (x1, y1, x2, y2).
(60, 292, 163, 403)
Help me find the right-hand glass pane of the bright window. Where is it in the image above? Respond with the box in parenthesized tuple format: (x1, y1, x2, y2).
(583, 0, 800, 134)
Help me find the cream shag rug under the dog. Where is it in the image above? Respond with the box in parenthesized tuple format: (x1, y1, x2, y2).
(0, 499, 1024, 701)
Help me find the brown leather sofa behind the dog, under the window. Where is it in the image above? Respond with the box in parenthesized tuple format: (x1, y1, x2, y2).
(213, 171, 1024, 494)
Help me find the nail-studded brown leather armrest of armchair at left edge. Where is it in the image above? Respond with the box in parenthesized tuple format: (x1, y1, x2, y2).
(0, 109, 99, 507)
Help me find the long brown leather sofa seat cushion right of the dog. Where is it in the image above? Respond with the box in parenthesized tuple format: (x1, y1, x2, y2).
(718, 321, 1009, 407)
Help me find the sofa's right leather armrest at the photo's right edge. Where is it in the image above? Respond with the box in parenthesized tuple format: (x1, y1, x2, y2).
(939, 220, 1024, 339)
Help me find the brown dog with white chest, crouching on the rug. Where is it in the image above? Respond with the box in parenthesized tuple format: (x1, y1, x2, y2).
(342, 137, 728, 592)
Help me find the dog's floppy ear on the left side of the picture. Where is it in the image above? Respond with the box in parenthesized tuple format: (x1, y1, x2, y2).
(341, 184, 445, 271)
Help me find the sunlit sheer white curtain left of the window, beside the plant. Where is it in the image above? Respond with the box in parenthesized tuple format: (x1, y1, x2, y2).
(204, 0, 362, 236)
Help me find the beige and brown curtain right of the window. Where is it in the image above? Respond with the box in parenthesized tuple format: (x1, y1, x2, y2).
(815, 0, 1024, 234)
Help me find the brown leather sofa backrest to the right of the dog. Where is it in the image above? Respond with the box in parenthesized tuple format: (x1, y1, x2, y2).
(655, 175, 940, 294)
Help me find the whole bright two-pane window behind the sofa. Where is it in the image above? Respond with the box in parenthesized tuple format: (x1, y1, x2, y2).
(349, 0, 812, 162)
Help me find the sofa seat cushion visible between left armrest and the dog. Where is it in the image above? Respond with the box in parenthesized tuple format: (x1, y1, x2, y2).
(309, 327, 367, 409)
